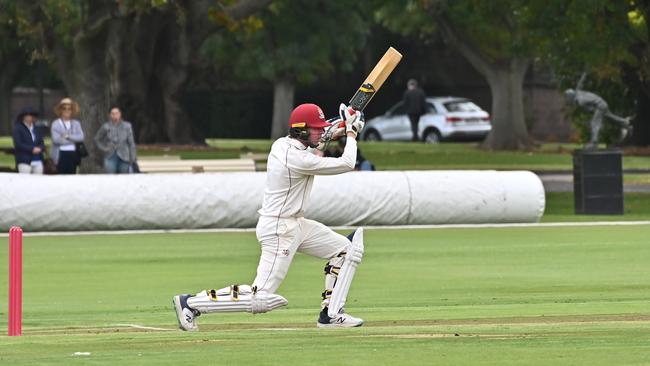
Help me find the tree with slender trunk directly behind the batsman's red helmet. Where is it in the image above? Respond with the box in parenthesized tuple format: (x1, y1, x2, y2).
(204, 0, 369, 138)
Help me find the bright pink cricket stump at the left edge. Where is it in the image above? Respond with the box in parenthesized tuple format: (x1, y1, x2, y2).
(7, 226, 23, 336)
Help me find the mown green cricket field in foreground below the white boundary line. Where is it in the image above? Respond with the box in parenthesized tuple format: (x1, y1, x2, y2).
(0, 225, 650, 365)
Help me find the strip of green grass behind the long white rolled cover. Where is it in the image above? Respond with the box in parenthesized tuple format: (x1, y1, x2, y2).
(0, 137, 650, 172)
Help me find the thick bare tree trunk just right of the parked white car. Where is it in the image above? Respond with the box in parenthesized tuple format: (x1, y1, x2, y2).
(481, 59, 531, 150)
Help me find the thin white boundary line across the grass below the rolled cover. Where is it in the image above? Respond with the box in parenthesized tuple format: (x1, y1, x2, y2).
(0, 221, 650, 238)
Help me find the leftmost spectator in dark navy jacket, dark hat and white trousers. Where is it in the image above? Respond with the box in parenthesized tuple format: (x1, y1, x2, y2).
(13, 107, 45, 174)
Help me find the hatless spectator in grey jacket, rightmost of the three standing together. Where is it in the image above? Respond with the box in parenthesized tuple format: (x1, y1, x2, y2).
(95, 107, 136, 174)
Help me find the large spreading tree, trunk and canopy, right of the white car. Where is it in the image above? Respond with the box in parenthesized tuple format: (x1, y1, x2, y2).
(377, 0, 627, 149)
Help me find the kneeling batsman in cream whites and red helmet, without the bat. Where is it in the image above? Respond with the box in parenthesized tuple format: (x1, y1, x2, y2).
(173, 104, 364, 331)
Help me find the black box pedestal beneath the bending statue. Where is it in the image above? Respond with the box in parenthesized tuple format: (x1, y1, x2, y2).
(573, 149, 623, 215)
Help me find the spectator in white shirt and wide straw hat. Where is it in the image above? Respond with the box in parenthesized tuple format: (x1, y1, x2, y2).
(51, 98, 84, 174)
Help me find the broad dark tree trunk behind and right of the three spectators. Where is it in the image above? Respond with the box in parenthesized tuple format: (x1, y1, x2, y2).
(108, 10, 197, 144)
